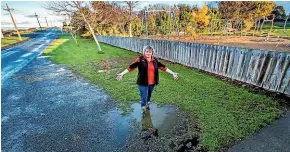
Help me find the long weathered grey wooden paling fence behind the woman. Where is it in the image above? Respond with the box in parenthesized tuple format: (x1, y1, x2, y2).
(97, 36, 290, 95)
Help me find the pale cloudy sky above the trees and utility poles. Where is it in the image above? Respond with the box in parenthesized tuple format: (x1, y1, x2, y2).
(1, 1, 290, 28)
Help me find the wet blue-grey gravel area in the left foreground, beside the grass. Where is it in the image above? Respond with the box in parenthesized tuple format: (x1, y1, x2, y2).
(1, 58, 132, 152)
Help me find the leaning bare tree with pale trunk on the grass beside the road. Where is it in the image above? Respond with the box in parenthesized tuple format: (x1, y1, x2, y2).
(43, 1, 102, 51)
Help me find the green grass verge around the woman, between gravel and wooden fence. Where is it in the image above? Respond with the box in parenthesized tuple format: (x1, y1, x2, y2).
(45, 36, 283, 151)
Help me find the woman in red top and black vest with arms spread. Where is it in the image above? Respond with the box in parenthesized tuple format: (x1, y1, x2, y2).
(117, 45, 178, 110)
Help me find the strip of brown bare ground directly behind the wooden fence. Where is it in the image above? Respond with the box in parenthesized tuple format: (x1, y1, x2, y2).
(149, 36, 290, 52)
